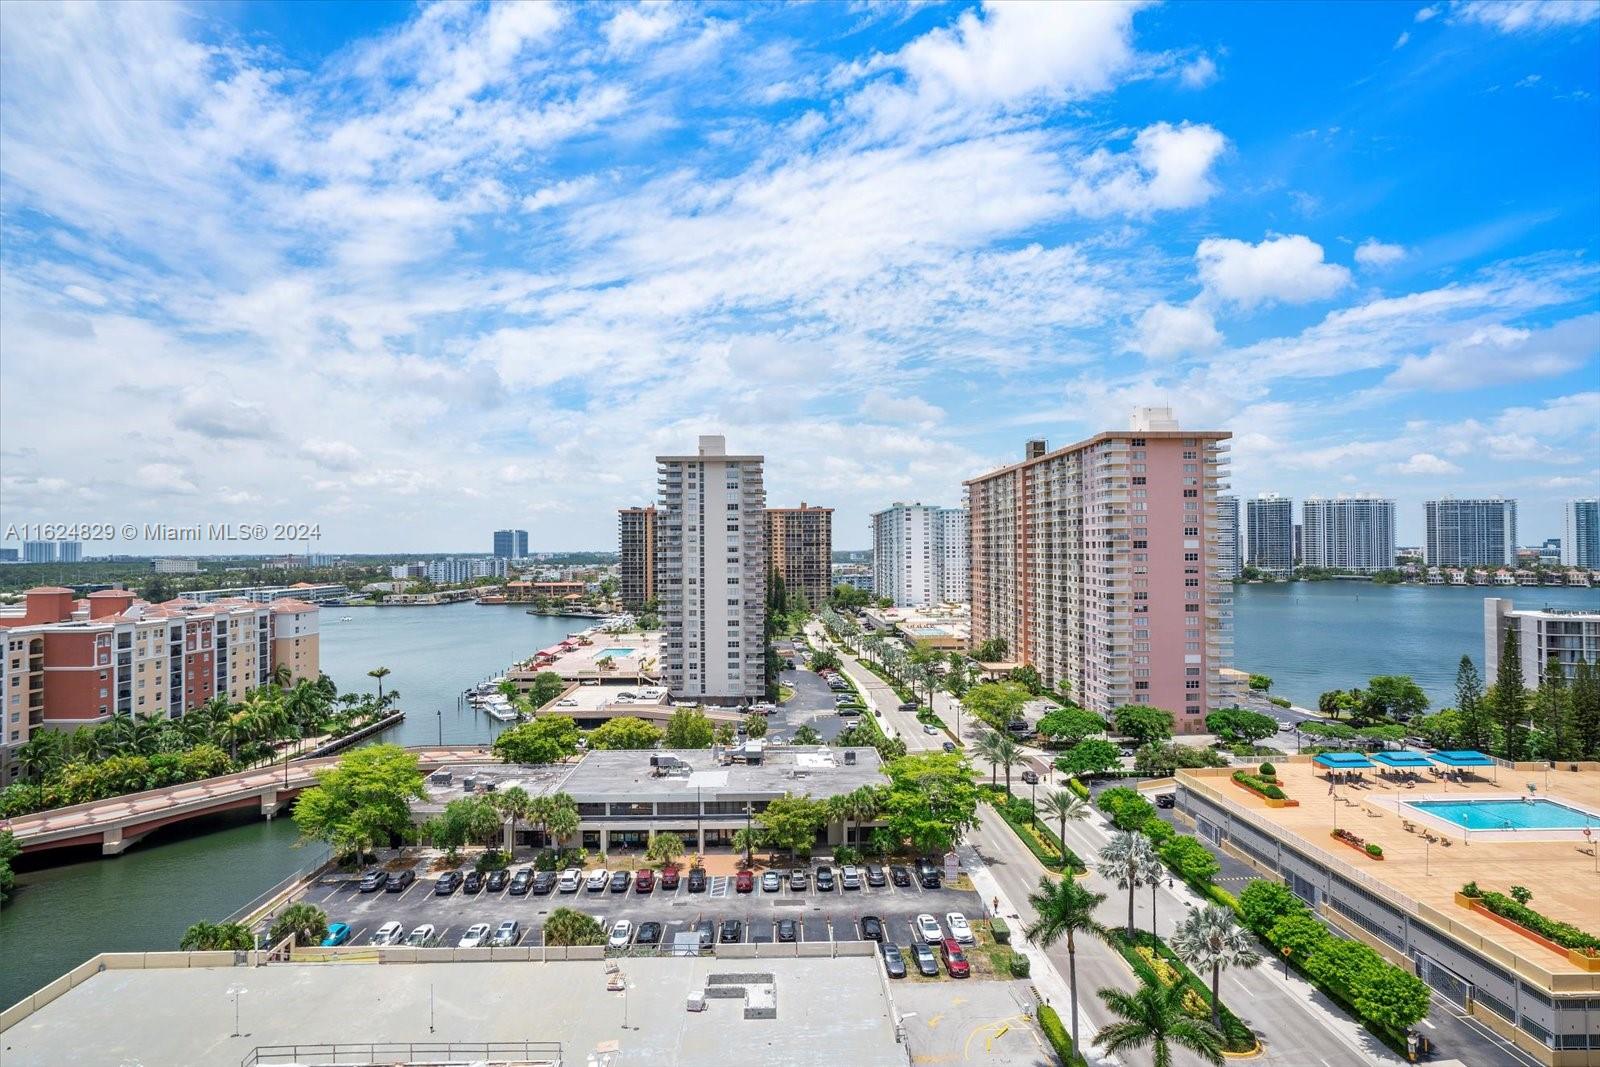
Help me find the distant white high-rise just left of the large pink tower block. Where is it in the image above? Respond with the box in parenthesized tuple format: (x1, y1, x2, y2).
(872, 501, 971, 608)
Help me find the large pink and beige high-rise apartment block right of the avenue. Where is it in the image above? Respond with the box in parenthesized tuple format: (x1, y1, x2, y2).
(966, 408, 1232, 733)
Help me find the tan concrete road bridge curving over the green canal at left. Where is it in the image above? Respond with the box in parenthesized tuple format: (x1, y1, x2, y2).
(0, 745, 488, 856)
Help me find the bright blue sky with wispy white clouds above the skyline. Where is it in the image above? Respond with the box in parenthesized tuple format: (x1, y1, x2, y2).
(0, 0, 1600, 552)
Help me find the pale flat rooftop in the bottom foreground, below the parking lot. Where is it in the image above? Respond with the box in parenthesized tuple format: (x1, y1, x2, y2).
(0, 957, 906, 1067)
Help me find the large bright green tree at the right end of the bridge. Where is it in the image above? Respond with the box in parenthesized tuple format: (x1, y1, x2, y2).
(294, 745, 427, 856)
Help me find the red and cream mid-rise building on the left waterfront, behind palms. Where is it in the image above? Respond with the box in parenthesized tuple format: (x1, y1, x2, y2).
(0, 585, 320, 785)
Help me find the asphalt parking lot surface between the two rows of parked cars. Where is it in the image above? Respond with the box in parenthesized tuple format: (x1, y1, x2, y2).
(301, 867, 984, 945)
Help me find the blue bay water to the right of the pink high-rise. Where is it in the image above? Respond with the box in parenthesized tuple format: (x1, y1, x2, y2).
(1234, 582, 1600, 707)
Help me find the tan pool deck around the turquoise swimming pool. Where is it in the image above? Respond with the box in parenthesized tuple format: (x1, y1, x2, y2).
(1181, 757, 1600, 979)
